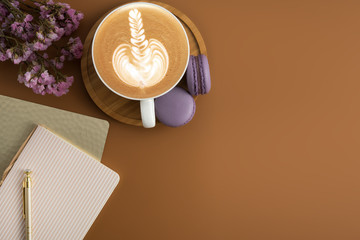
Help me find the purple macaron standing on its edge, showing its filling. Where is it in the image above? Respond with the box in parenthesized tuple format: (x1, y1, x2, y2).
(186, 54, 211, 96)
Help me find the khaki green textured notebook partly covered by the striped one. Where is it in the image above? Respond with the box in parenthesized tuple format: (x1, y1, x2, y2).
(0, 95, 109, 176)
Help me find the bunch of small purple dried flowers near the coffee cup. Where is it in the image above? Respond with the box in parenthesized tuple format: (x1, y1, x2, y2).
(0, 0, 84, 96)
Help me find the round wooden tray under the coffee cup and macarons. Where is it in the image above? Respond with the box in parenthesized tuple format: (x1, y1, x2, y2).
(81, 1, 207, 126)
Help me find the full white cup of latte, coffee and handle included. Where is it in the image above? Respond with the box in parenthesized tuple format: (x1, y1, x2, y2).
(92, 2, 190, 110)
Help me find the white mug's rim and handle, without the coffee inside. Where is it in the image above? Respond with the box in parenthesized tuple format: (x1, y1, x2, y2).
(91, 2, 190, 128)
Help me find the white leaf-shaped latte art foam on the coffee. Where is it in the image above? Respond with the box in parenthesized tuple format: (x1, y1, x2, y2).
(112, 9, 169, 88)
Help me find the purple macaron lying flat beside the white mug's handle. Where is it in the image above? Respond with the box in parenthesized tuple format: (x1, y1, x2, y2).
(155, 87, 196, 127)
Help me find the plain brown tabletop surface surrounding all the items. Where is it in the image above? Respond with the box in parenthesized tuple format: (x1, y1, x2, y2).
(0, 0, 360, 240)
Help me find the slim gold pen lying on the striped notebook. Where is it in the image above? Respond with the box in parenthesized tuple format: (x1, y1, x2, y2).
(23, 170, 32, 240)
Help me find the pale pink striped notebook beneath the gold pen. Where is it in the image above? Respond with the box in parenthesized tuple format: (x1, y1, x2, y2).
(0, 126, 119, 240)
